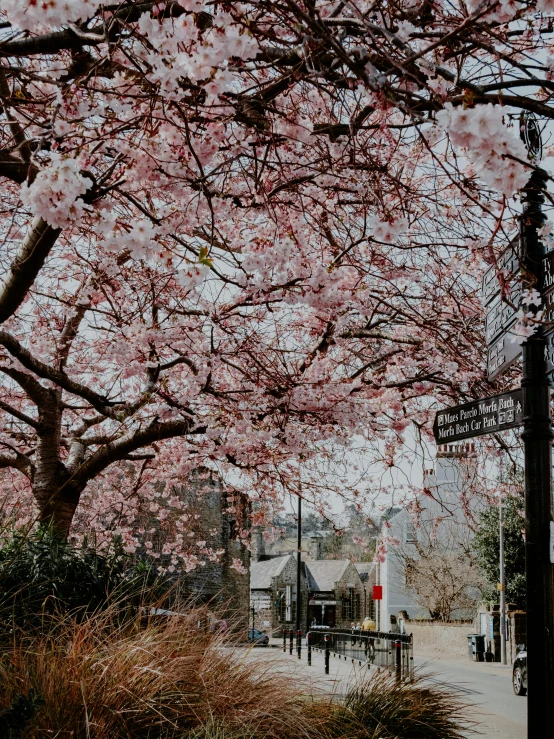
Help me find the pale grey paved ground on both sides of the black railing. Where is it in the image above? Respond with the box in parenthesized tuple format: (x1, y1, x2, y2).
(247, 639, 527, 739)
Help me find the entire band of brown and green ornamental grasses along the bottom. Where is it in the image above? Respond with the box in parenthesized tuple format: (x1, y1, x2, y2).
(0, 604, 471, 739)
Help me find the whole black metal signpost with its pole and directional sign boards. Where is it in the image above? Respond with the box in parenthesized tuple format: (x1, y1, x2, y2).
(433, 169, 554, 739)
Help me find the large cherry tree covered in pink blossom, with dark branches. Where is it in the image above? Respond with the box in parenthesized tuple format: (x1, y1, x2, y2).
(0, 0, 554, 548)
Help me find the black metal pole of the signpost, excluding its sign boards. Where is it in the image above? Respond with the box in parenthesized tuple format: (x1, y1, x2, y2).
(521, 169, 554, 739)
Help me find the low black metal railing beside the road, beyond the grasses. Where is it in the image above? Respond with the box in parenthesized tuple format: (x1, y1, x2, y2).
(300, 628, 414, 679)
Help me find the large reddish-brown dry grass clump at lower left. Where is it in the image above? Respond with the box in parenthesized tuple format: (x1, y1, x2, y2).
(0, 608, 324, 739)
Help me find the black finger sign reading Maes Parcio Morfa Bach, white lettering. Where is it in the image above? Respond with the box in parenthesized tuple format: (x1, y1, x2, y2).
(433, 390, 523, 444)
